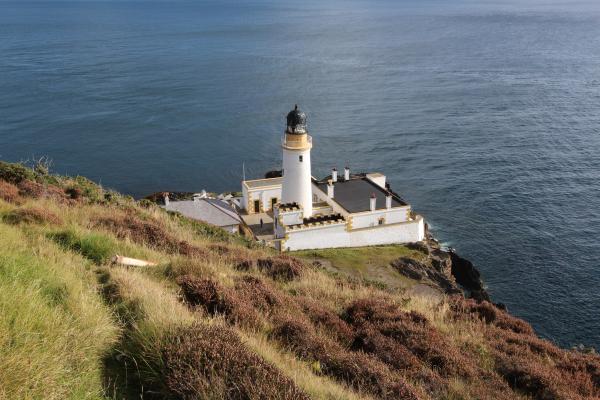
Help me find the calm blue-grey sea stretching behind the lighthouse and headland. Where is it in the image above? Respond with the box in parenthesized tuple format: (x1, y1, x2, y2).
(0, 0, 600, 348)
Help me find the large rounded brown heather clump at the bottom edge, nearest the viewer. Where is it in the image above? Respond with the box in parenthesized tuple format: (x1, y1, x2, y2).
(162, 325, 309, 400)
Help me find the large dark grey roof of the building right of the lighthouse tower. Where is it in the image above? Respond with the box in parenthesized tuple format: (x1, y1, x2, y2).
(314, 177, 408, 213)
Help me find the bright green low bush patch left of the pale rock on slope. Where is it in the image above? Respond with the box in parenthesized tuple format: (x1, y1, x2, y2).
(48, 230, 116, 265)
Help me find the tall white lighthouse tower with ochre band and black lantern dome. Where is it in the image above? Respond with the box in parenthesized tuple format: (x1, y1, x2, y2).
(281, 105, 312, 218)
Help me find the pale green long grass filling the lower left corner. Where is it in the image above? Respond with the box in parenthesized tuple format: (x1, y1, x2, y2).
(0, 224, 117, 399)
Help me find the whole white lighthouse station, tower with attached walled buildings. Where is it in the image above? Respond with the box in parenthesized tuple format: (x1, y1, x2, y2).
(242, 106, 425, 251)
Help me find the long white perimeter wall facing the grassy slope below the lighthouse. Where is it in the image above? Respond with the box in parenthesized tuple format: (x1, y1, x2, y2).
(283, 217, 425, 251)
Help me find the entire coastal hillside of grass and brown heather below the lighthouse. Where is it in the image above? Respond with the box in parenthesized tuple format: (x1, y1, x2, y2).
(0, 163, 600, 399)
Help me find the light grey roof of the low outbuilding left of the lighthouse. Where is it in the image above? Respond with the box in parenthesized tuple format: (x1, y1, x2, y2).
(165, 199, 241, 226)
